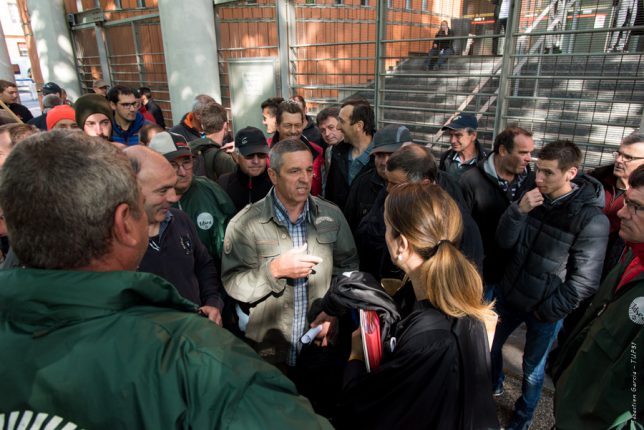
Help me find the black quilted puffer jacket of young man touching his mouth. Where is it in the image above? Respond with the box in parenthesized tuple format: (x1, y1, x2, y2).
(496, 174, 608, 322)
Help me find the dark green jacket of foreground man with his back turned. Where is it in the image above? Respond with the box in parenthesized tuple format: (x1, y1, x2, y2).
(0, 269, 331, 430)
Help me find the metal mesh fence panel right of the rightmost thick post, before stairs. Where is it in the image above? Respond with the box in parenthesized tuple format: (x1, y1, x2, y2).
(501, 0, 644, 167)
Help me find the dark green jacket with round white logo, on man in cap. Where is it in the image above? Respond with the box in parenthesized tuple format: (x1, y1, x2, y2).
(174, 176, 237, 266)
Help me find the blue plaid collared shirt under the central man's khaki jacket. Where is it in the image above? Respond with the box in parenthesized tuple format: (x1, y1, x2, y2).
(271, 189, 309, 366)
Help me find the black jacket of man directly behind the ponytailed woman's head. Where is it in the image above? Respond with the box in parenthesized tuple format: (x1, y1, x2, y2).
(353, 189, 483, 280)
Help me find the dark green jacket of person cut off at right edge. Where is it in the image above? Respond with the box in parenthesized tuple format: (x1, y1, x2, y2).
(553, 251, 644, 430)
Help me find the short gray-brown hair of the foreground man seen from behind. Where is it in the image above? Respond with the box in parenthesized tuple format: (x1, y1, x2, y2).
(0, 130, 143, 270)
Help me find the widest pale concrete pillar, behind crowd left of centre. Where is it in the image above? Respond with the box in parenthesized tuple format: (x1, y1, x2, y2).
(158, 0, 221, 124)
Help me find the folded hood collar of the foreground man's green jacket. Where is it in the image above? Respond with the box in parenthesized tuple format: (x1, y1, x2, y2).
(0, 268, 197, 336)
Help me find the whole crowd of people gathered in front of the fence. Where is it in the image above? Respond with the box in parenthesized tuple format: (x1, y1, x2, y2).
(0, 77, 644, 429)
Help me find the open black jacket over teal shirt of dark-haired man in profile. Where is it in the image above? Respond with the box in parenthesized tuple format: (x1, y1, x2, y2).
(324, 141, 375, 208)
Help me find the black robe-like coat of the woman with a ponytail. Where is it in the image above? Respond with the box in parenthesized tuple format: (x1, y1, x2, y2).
(332, 300, 499, 430)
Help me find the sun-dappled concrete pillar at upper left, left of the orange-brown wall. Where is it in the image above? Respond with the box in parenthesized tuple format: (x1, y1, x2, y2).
(27, 0, 82, 99)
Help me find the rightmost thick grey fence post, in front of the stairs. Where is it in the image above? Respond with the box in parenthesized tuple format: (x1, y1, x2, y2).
(492, 1, 521, 140)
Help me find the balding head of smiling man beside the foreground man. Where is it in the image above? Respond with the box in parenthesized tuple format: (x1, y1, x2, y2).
(124, 145, 179, 228)
